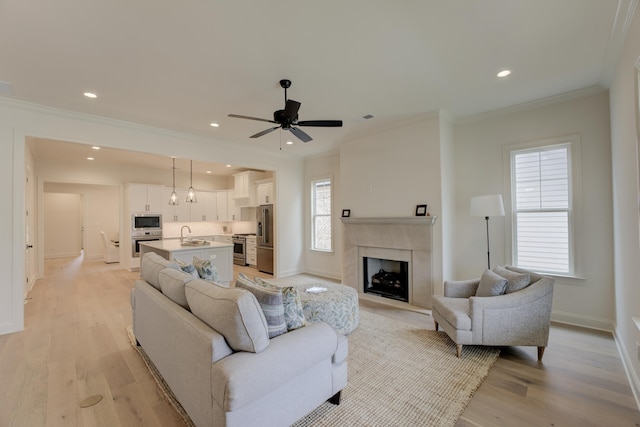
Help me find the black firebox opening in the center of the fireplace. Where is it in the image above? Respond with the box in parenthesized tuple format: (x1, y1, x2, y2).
(362, 257, 409, 302)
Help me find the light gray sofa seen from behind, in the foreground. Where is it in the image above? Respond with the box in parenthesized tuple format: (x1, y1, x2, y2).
(131, 253, 348, 427)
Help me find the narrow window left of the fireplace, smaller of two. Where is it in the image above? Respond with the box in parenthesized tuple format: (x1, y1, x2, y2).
(311, 178, 332, 252)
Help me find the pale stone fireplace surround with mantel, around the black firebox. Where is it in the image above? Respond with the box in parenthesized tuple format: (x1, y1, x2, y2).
(342, 216, 437, 308)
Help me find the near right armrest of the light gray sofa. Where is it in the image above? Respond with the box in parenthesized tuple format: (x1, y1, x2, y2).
(211, 323, 338, 411)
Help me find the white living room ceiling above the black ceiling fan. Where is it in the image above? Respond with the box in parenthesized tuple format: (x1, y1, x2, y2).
(0, 0, 636, 169)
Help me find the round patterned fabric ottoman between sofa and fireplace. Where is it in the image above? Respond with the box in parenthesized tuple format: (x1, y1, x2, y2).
(295, 283, 360, 335)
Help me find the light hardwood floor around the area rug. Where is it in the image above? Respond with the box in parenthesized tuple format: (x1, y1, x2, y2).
(0, 258, 640, 427)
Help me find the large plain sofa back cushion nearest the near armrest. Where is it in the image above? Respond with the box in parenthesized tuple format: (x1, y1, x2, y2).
(185, 279, 269, 353)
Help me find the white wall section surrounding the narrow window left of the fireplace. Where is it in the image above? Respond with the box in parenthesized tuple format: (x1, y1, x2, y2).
(304, 152, 344, 279)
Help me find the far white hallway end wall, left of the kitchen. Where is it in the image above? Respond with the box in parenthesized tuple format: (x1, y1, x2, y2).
(43, 193, 83, 258)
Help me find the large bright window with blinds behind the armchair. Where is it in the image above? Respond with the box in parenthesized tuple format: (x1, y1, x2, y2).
(510, 140, 574, 275)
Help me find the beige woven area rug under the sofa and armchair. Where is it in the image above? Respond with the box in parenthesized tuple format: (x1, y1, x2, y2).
(133, 310, 499, 427)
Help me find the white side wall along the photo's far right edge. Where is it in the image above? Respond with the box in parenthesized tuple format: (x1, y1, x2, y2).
(610, 5, 640, 408)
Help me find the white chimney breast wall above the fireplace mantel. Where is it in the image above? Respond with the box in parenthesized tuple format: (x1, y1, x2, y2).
(339, 112, 450, 289)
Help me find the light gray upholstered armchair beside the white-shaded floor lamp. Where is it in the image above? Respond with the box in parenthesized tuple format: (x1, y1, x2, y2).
(432, 266, 555, 361)
